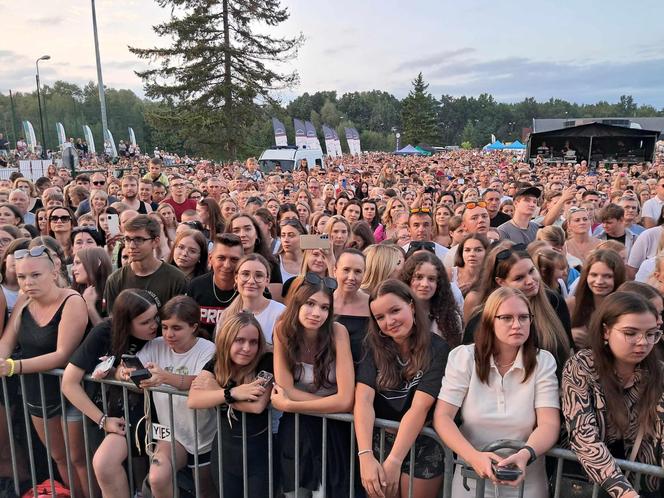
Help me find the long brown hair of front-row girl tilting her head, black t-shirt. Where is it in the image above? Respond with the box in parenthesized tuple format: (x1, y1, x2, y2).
(365, 279, 431, 390)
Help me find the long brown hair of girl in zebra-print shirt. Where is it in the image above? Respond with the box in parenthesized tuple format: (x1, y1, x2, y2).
(588, 291, 664, 434)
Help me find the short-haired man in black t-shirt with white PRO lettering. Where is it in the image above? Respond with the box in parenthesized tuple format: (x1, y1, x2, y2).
(187, 233, 244, 338)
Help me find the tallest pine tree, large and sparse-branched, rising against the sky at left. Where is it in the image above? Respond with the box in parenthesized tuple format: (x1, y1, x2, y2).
(129, 0, 303, 157)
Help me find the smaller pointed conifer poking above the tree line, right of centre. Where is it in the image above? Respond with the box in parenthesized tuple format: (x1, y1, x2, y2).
(401, 73, 440, 145)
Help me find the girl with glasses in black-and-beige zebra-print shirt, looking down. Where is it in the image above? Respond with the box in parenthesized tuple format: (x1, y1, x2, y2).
(562, 291, 664, 498)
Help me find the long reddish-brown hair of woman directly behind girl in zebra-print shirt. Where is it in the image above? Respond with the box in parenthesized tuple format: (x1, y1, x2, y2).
(572, 249, 625, 327)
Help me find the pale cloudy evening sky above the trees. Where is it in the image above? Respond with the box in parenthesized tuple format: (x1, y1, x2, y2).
(0, 0, 664, 108)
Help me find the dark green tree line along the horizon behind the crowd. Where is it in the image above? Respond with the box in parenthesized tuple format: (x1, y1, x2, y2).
(0, 74, 664, 158)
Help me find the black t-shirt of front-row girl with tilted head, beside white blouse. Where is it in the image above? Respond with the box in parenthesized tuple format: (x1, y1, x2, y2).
(355, 334, 450, 422)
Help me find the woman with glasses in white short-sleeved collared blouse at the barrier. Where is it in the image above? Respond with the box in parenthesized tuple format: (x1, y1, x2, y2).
(433, 287, 560, 498)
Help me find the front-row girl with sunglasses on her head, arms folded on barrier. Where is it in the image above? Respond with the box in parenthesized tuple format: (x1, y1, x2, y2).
(272, 273, 355, 497)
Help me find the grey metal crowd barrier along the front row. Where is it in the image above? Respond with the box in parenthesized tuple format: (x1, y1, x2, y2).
(0, 369, 664, 498)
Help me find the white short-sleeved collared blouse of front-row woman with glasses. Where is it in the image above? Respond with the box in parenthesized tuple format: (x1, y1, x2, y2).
(438, 344, 560, 498)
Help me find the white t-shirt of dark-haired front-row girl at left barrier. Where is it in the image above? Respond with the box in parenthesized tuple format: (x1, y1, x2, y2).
(136, 337, 217, 455)
